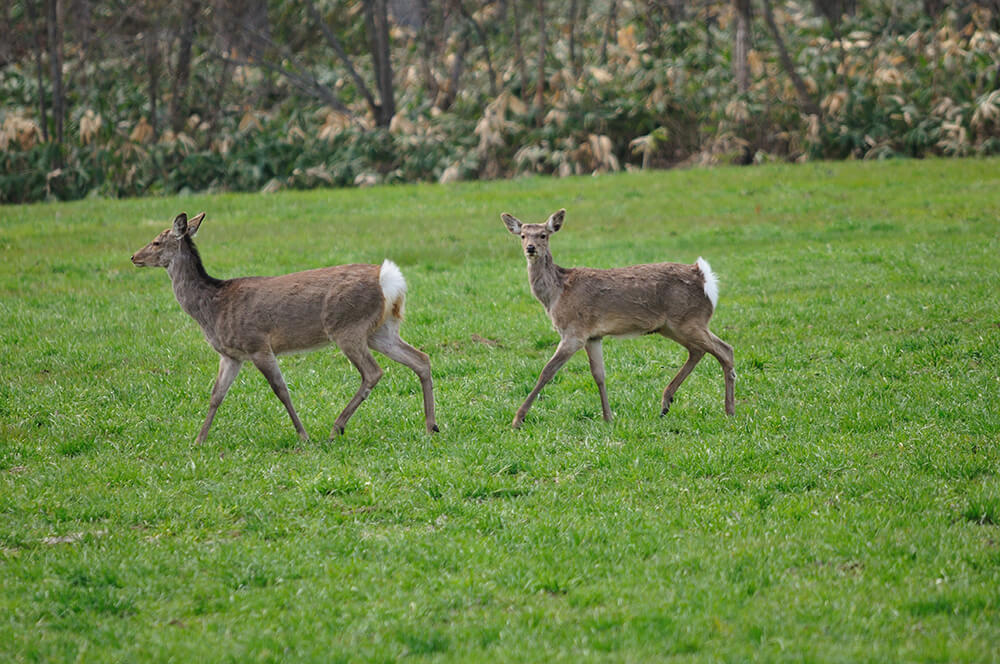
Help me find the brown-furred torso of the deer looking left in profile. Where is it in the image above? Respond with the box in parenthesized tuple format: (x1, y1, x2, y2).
(206, 264, 384, 356)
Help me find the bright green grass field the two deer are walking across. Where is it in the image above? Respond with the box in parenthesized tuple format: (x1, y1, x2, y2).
(0, 161, 1000, 662)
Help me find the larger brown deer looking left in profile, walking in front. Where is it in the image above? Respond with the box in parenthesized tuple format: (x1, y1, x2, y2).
(132, 212, 438, 444)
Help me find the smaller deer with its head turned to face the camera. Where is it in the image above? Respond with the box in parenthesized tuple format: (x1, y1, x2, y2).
(500, 209, 736, 429)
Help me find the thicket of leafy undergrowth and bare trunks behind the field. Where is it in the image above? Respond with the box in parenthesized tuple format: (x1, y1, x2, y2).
(0, 0, 1000, 202)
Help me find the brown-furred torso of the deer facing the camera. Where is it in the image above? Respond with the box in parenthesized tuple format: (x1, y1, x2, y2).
(550, 263, 712, 337)
